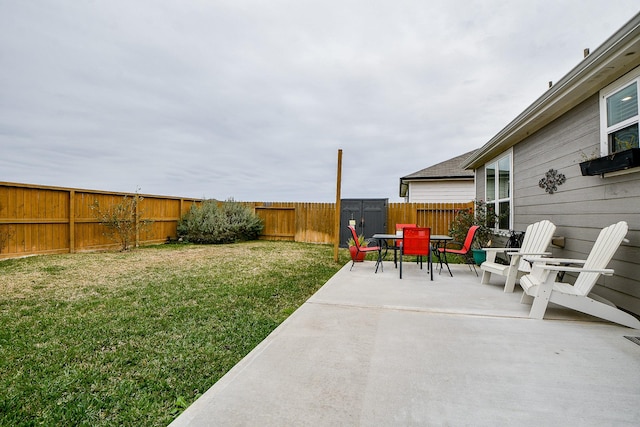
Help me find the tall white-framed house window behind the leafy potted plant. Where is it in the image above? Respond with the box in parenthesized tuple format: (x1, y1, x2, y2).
(485, 152, 512, 230)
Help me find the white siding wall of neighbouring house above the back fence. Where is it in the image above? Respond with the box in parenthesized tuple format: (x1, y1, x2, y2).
(408, 180, 475, 203)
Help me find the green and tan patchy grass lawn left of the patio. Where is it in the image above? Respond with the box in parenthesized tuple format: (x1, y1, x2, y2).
(0, 241, 348, 426)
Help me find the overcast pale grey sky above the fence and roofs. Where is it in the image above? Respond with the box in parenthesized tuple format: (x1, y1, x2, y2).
(0, 0, 639, 202)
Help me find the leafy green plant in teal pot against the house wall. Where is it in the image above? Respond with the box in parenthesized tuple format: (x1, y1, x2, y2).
(449, 200, 499, 265)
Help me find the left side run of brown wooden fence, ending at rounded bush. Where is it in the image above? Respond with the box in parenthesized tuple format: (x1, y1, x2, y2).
(0, 182, 200, 258)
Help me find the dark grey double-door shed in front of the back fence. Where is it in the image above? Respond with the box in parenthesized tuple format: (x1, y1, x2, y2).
(340, 199, 389, 248)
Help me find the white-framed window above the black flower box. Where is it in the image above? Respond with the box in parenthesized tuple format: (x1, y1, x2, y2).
(600, 70, 640, 156)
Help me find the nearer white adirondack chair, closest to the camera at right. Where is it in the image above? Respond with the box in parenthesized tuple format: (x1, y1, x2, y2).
(520, 221, 640, 329)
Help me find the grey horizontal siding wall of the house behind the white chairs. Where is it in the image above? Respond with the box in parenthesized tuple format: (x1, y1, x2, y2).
(476, 94, 640, 315)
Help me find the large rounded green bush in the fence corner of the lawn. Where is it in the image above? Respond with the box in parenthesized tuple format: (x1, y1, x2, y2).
(178, 199, 263, 244)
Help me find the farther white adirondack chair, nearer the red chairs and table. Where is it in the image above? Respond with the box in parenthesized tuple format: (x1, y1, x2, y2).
(480, 219, 556, 292)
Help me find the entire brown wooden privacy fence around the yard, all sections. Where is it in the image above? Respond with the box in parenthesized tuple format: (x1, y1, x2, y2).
(0, 182, 473, 258)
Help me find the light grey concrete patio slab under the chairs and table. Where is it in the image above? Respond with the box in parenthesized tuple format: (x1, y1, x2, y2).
(171, 262, 640, 427)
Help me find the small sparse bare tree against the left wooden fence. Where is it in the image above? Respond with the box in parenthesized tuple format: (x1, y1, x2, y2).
(90, 191, 153, 251)
